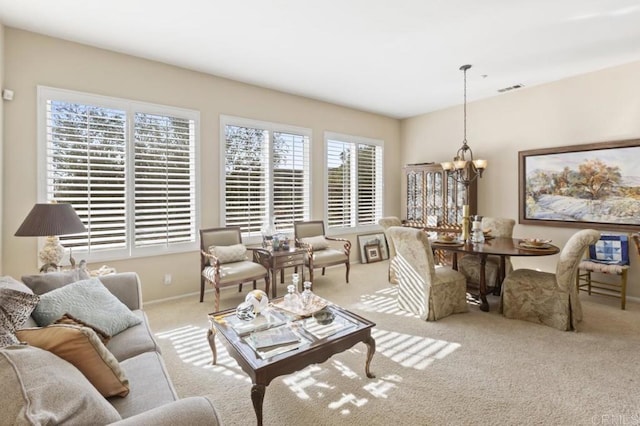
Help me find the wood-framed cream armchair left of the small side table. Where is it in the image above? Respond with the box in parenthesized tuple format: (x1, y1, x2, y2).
(200, 226, 269, 311)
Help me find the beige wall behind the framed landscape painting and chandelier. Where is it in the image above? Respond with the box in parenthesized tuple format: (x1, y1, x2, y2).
(401, 62, 640, 297)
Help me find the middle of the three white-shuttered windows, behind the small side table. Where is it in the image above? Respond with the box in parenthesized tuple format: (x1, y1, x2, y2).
(220, 116, 311, 236)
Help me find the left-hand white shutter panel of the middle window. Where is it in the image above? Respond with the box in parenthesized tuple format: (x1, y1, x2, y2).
(225, 125, 270, 235)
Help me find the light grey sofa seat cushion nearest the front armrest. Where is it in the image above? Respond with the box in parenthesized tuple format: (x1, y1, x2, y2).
(109, 352, 178, 419)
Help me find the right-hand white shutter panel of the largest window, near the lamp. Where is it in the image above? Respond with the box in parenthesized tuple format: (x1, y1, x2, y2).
(133, 112, 196, 248)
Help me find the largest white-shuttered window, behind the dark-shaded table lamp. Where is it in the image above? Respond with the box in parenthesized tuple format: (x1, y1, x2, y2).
(38, 87, 199, 261)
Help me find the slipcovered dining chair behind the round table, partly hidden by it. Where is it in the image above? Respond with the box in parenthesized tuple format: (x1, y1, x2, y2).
(458, 217, 516, 294)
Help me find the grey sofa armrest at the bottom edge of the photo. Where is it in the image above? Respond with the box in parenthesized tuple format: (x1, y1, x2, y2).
(112, 396, 222, 426)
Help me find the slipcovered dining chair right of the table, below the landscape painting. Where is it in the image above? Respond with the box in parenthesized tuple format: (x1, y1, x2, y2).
(500, 229, 600, 330)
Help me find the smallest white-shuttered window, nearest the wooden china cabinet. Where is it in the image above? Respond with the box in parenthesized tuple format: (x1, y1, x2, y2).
(325, 133, 383, 228)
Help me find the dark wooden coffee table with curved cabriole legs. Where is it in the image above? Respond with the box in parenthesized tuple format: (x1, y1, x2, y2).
(207, 299, 376, 425)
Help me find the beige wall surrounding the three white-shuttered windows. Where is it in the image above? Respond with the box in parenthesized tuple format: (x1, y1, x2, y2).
(2, 28, 400, 300)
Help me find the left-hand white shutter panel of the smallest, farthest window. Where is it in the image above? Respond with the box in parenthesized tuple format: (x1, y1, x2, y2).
(327, 140, 355, 228)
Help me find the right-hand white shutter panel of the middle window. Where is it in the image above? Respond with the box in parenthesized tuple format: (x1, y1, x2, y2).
(273, 132, 310, 232)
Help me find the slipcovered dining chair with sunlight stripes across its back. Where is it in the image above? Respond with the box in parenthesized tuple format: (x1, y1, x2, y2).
(387, 226, 469, 321)
